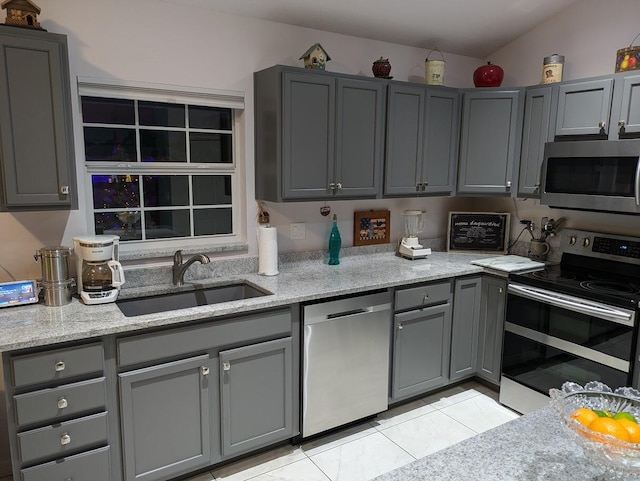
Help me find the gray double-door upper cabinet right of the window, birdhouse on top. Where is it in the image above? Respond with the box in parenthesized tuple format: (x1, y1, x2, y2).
(254, 66, 385, 202)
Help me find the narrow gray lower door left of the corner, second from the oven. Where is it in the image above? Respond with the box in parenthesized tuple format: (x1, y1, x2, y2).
(449, 277, 482, 381)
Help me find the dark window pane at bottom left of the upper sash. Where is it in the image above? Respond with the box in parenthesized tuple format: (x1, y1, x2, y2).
(84, 127, 137, 162)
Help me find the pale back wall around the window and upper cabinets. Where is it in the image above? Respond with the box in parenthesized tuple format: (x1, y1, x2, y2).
(0, 0, 482, 282)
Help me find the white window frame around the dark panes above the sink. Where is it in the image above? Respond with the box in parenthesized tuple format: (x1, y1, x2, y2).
(78, 77, 246, 256)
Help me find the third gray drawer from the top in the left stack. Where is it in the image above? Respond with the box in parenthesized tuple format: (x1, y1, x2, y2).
(18, 413, 107, 464)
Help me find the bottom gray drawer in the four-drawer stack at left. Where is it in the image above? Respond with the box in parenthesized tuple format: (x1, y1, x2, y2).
(20, 446, 111, 481)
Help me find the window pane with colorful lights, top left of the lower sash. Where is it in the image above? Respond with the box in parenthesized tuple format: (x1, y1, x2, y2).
(91, 175, 140, 209)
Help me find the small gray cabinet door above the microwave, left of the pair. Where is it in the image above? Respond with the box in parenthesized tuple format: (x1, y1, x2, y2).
(556, 77, 613, 137)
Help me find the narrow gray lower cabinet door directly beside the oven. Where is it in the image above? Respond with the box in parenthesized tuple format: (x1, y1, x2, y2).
(476, 276, 507, 384)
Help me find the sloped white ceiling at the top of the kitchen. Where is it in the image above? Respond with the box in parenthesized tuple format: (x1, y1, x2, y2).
(168, 0, 578, 58)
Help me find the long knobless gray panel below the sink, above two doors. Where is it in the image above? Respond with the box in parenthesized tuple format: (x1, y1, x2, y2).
(118, 309, 291, 366)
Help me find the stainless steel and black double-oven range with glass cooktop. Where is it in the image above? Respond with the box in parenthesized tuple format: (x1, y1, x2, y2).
(500, 229, 640, 413)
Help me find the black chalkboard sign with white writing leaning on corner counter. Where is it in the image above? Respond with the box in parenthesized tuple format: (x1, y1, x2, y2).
(447, 212, 510, 254)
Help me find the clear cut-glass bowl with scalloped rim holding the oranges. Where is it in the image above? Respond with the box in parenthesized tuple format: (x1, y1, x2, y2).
(549, 381, 640, 480)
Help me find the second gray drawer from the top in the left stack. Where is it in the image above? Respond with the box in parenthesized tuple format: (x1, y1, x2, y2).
(13, 377, 106, 426)
